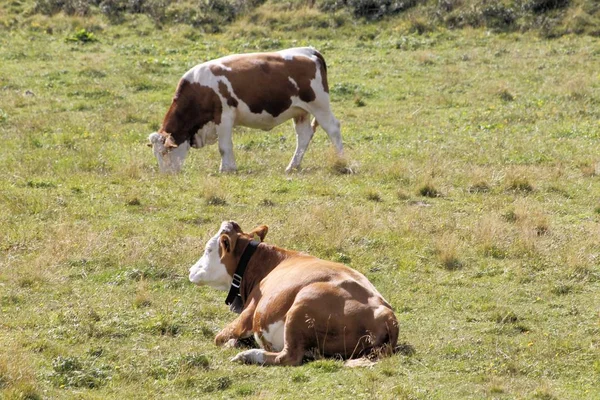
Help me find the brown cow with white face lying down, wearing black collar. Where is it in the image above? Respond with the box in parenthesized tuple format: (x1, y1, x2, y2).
(190, 221, 398, 365)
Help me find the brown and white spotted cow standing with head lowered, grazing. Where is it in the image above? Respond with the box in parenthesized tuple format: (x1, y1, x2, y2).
(149, 47, 342, 172)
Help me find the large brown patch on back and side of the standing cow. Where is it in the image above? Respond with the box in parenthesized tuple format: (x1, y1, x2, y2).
(210, 53, 318, 117)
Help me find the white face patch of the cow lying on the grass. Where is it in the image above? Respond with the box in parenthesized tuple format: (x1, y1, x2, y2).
(189, 222, 232, 290)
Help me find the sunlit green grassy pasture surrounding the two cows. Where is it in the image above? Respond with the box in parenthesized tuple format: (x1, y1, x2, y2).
(0, 1, 600, 399)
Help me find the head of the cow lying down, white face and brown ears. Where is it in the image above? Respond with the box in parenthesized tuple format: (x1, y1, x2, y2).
(190, 221, 268, 290)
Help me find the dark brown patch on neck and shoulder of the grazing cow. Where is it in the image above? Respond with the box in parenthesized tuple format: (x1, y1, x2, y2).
(159, 79, 223, 145)
